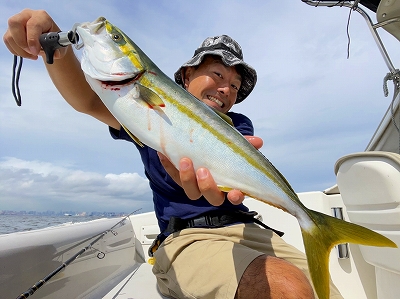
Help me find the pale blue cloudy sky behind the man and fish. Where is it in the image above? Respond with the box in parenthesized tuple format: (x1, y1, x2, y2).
(0, 0, 400, 212)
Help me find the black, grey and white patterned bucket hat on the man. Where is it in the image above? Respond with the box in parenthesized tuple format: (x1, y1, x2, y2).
(175, 35, 257, 104)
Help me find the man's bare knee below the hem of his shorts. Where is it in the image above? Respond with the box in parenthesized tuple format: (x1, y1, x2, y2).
(235, 255, 314, 299)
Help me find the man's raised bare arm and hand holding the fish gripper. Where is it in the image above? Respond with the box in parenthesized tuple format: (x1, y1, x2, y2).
(3, 9, 121, 130)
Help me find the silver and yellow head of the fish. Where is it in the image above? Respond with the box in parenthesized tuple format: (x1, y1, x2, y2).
(76, 17, 144, 82)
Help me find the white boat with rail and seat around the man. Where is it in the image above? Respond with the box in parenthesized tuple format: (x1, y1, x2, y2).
(0, 0, 400, 299)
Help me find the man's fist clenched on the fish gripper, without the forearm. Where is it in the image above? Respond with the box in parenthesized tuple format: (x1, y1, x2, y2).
(3, 9, 67, 60)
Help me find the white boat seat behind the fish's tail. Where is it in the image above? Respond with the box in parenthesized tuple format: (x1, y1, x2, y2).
(335, 151, 400, 299)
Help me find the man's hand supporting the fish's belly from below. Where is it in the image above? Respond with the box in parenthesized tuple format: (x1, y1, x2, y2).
(158, 136, 263, 206)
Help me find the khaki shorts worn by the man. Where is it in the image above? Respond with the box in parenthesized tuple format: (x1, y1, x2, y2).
(153, 224, 342, 299)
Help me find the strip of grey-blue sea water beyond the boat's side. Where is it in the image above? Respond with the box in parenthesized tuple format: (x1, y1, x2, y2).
(0, 215, 104, 235)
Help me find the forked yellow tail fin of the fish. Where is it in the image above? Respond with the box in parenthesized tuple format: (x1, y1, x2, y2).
(300, 210, 397, 299)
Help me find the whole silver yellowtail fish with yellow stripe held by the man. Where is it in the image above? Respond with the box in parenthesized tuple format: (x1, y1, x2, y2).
(77, 18, 397, 299)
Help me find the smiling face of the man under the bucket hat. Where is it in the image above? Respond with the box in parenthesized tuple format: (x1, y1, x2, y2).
(184, 56, 242, 113)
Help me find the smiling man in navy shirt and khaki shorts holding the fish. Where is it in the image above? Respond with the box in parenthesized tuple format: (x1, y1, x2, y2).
(3, 9, 341, 299)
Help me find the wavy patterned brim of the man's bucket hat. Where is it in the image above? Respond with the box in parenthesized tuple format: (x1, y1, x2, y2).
(174, 49, 257, 104)
